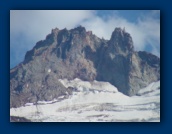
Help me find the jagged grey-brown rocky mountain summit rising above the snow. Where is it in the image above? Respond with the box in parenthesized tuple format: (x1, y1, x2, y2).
(10, 26, 160, 107)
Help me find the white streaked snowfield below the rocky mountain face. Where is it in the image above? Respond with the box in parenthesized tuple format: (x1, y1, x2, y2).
(10, 79, 160, 122)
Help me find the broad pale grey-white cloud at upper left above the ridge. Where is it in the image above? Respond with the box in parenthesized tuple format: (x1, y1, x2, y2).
(10, 10, 93, 41)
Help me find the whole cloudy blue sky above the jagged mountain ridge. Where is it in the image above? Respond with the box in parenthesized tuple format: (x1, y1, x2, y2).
(10, 10, 160, 68)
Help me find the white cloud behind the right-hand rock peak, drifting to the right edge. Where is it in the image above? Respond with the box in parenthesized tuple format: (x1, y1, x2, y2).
(82, 11, 160, 56)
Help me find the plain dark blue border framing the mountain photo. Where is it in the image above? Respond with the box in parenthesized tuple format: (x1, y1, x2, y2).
(0, 0, 172, 134)
